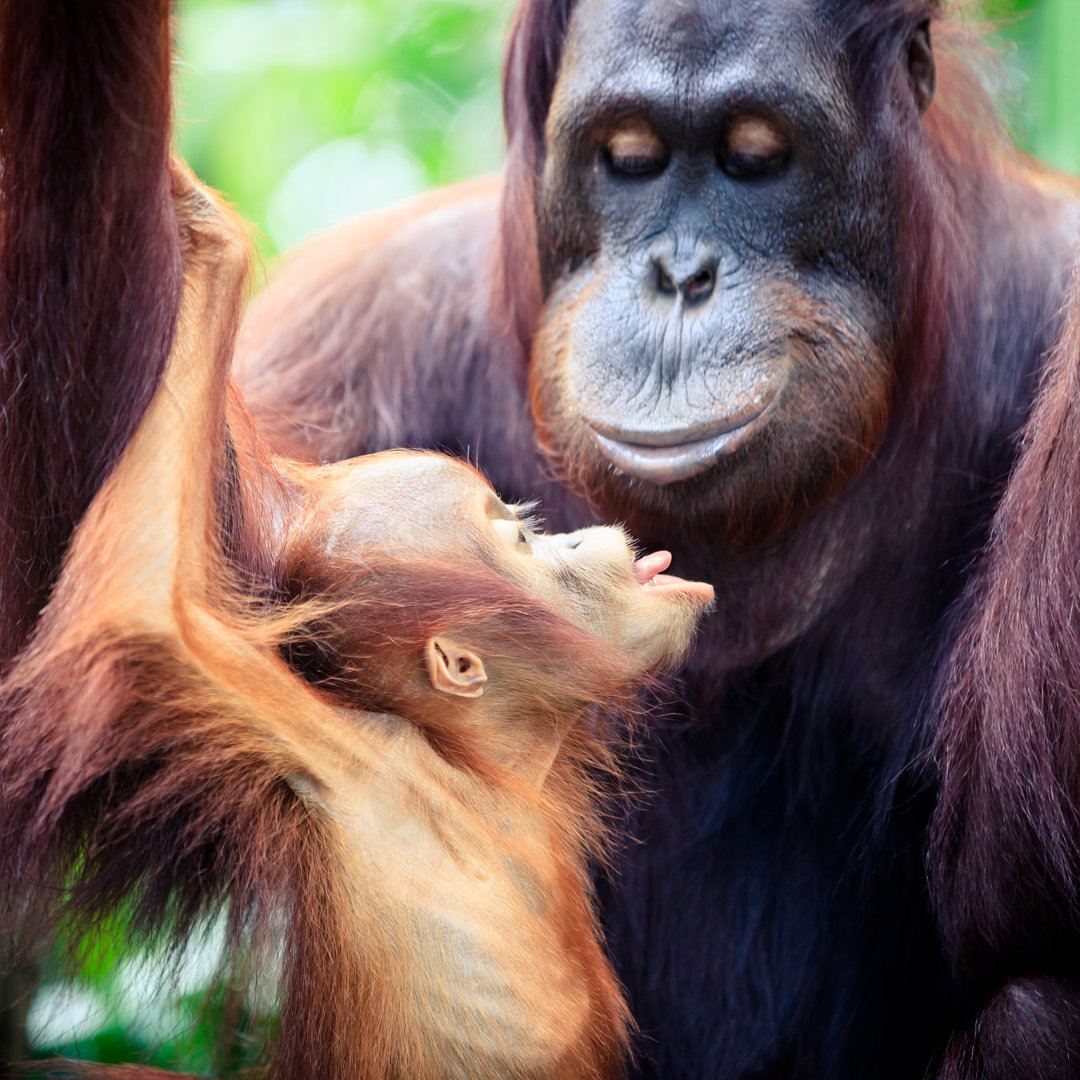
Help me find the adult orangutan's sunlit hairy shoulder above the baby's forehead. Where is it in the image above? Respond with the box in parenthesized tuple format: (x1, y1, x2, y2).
(235, 177, 509, 460)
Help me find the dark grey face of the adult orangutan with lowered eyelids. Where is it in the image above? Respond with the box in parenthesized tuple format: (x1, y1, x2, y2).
(532, 0, 902, 542)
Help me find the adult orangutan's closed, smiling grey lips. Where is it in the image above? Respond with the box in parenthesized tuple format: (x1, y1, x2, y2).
(588, 393, 779, 484)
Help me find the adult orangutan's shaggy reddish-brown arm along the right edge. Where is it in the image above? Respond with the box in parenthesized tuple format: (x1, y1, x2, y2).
(930, 263, 1080, 1080)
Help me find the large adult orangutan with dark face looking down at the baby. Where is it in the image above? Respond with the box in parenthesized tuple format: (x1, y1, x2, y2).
(240, 0, 1080, 1080)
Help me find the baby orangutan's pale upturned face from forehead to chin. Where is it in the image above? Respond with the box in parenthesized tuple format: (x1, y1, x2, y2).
(300, 450, 713, 665)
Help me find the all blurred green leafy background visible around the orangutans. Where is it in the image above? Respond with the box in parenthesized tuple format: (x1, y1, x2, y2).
(16, 0, 1080, 1072)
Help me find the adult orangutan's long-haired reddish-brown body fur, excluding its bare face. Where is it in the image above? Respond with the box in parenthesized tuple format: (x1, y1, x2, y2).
(238, 0, 1080, 1080)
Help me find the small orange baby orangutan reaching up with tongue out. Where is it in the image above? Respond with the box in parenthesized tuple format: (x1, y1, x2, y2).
(0, 164, 712, 1080)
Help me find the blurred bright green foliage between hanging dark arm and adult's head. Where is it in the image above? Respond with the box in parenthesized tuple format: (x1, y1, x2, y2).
(176, 0, 512, 252)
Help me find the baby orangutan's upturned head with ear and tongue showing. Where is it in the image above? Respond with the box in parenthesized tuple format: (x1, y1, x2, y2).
(286, 450, 713, 778)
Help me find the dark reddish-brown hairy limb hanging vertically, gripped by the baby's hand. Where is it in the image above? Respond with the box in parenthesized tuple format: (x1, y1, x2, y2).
(0, 0, 180, 665)
